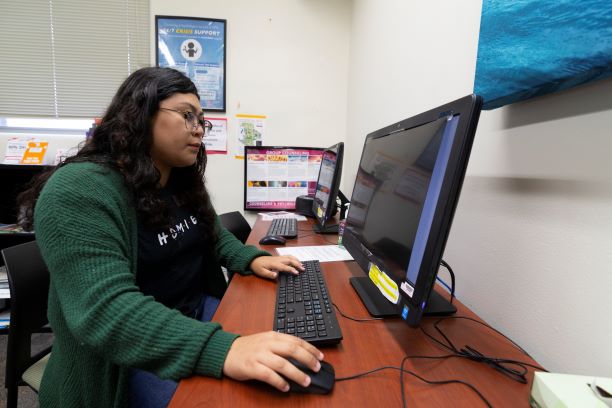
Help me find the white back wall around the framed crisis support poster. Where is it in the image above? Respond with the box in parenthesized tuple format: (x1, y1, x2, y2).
(150, 0, 351, 221)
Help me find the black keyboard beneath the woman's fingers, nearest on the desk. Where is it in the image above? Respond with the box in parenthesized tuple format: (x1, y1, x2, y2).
(273, 260, 342, 345)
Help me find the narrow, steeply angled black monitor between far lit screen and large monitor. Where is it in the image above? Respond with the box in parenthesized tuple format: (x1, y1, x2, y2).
(312, 142, 344, 234)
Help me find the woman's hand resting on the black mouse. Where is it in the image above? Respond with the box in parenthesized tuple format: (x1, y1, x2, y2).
(223, 331, 323, 392)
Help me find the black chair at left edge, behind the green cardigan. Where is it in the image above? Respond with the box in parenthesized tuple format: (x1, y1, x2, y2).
(2, 241, 51, 408)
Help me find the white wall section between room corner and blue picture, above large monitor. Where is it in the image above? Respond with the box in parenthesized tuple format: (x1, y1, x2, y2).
(342, 0, 480, 186)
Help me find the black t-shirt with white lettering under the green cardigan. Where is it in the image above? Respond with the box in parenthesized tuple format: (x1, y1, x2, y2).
(136, 189, 221, 315)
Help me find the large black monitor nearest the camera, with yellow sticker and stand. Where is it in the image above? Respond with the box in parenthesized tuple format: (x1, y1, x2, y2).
(342, 95, 482, 327)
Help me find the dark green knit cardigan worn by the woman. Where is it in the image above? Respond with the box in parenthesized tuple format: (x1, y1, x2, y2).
(34, 163, 268, 408)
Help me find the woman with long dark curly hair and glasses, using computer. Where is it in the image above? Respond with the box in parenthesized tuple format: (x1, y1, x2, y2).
(21, 68, 323, 407)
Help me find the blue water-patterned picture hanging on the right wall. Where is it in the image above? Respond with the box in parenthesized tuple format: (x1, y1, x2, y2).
(474, 0, 612, 109)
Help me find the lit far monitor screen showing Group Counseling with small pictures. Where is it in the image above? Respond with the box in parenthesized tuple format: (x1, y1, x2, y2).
(244, 146, 324, 211)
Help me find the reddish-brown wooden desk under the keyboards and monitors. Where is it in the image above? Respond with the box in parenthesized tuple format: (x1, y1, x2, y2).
(170, 219, 537, 408)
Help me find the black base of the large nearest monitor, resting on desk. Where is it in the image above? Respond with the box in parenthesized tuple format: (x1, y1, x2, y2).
(349, 276, 457, 317)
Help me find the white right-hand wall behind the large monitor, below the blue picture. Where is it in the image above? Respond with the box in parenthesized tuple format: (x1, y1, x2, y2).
(343, 0, 612, 377)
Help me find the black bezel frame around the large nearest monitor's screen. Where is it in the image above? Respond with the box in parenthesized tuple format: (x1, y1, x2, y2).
(343, 94, 482, 327)
